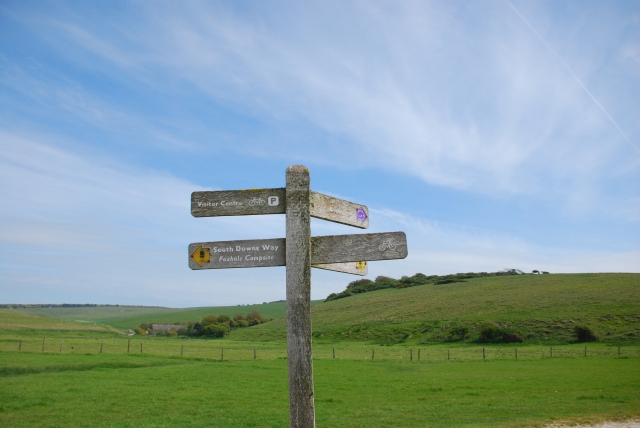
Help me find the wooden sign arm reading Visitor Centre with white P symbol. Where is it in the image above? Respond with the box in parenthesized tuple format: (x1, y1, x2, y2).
(191, 188, 286, 217)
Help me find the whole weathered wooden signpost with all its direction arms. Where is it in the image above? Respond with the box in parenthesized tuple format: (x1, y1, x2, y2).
(189, 165, 407, 428)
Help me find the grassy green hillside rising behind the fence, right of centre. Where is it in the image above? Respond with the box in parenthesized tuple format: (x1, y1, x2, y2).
(235, 274, 640, 343)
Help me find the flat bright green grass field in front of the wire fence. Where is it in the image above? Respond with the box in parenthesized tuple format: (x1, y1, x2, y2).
(0, 351, 640, 427)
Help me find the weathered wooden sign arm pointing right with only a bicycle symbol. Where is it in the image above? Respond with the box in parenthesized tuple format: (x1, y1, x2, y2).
(311, 232, 407, 264)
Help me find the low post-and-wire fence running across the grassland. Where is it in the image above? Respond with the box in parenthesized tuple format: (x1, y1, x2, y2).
(0, 337, 640, 362)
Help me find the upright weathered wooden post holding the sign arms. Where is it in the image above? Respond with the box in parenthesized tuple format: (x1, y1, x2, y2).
(286, 165, 315, 428)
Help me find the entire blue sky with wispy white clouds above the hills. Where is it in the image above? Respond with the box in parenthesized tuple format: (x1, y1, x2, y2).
(0, 0, 640, 307)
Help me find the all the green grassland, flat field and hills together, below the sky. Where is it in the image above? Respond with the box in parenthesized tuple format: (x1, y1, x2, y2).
(0, 274, 640, 427)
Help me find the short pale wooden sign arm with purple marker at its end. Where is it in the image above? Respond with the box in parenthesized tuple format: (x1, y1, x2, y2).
(311, 191, 369, 229)
